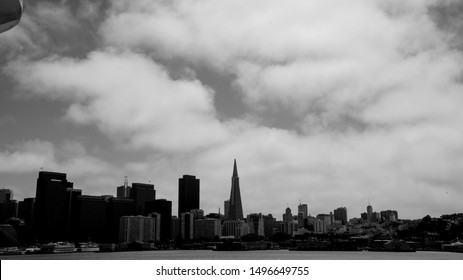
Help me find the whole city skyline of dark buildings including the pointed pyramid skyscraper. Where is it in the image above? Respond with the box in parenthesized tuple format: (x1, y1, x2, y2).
(0, 160, 424, 248)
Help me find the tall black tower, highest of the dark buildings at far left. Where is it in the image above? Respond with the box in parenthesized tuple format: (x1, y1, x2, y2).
(34, 171, 73, 243)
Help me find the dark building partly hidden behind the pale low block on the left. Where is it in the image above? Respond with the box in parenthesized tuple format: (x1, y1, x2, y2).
(106, 197, 136, 243)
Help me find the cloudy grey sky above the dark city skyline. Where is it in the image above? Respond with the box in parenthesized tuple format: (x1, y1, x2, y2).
(0, 0, 463, 219)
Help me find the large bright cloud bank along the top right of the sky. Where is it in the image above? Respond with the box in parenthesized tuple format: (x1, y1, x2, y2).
(101, 0, 462, 126)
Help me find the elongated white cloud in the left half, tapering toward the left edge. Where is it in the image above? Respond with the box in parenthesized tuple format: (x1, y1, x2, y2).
(9, 51, 227, 152)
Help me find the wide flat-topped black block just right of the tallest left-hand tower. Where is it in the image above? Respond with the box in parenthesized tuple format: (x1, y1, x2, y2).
(75, 195, 110, 243)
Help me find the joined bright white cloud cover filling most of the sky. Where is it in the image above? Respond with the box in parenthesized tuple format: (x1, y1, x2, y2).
(3, 0, 463, 218)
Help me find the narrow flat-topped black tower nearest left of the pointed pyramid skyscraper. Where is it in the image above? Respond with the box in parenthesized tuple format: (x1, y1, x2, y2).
(178, 175, 199, 217)
